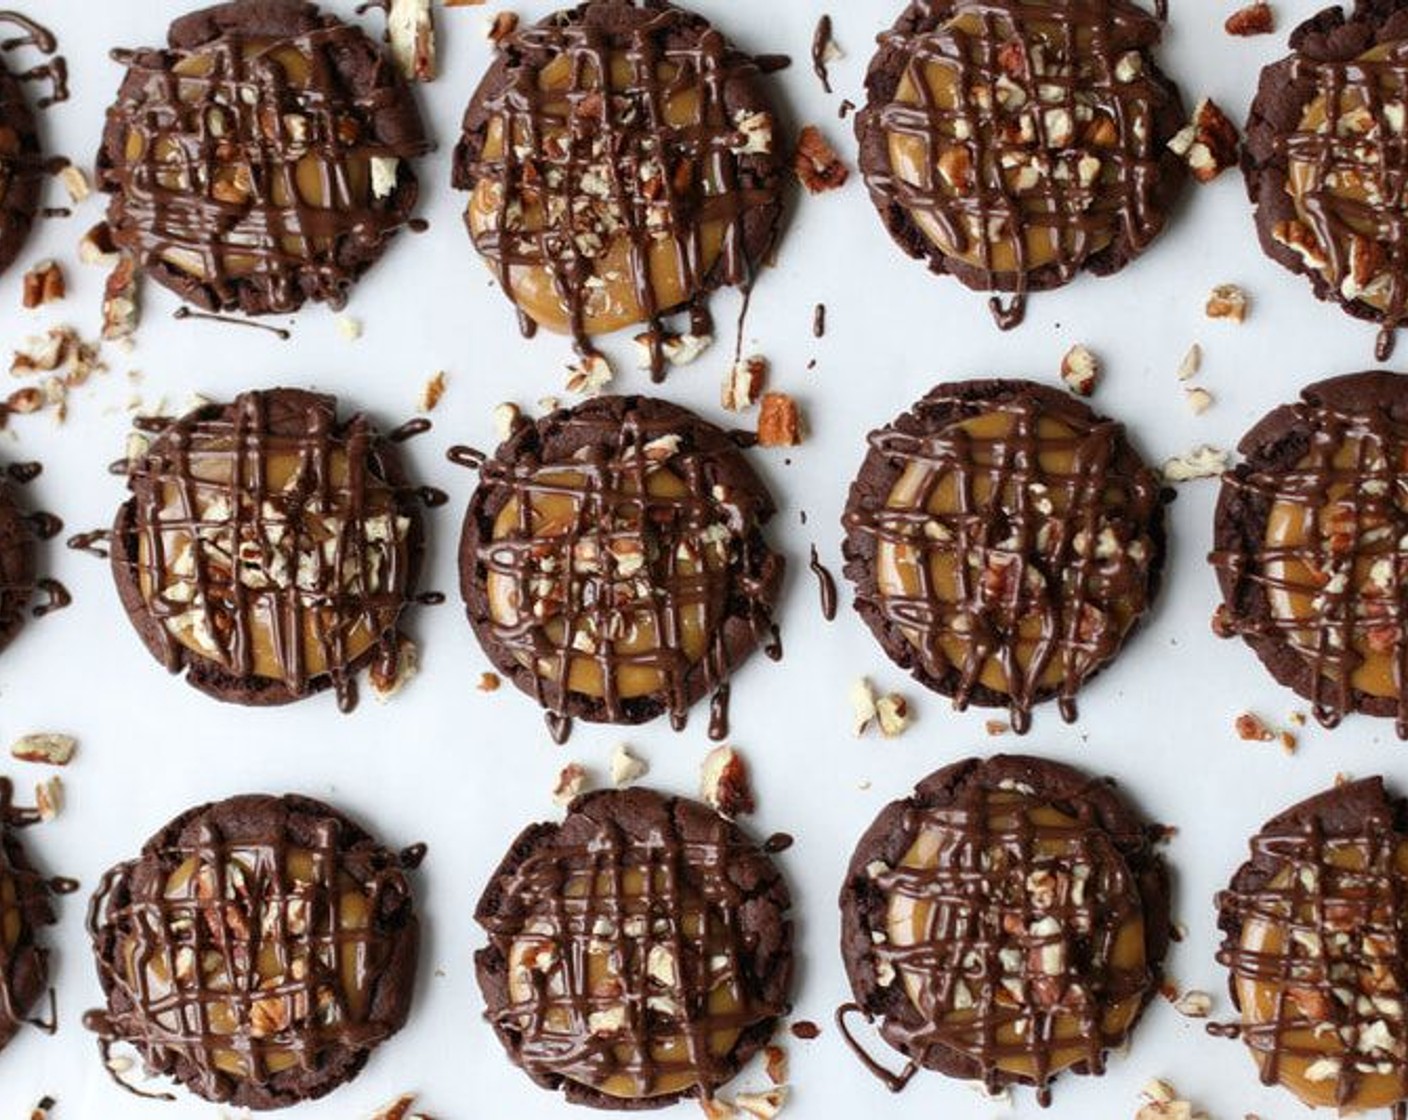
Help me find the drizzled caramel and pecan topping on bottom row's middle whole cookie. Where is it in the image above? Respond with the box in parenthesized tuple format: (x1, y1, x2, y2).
(490, 800, 780, 1100)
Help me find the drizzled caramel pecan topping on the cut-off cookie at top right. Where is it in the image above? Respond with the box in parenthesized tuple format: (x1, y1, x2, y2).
(1289, 41, 1408, 330)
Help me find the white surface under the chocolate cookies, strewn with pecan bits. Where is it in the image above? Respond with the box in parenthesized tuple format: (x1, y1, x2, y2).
(0, 0, 1408, 1120)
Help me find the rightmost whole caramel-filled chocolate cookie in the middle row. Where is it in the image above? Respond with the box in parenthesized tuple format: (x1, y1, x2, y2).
(842, 380, 1169, 731)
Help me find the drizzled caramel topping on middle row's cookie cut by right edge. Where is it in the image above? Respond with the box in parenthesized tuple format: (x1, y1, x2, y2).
(1212, 394, 1408, 734)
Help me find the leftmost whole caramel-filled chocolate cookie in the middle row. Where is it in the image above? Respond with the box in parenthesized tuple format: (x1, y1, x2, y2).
(111, 389, 424, 710)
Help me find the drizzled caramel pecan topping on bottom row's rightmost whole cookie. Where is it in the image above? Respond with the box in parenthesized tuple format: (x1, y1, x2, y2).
(869, 783, 1155, 1090)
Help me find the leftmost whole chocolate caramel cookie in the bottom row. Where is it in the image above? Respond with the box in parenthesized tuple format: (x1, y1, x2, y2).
(84, 796, 420, 1109)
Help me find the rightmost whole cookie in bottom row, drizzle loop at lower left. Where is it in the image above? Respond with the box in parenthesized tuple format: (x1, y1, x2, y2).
(838, 755, 1170, 1103)
